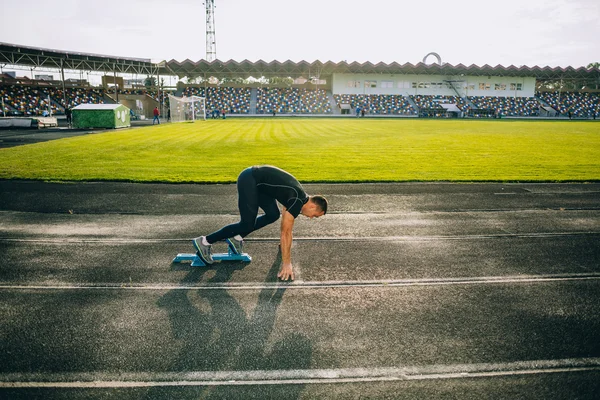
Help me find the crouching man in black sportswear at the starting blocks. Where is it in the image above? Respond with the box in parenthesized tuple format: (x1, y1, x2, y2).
(192, 165, 327, 281)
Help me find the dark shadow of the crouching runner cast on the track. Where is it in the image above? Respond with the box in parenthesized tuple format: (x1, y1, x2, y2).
(146, 251, 313, 400)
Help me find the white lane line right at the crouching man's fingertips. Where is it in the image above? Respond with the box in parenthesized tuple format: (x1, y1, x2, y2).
(0, 272, 600, 290)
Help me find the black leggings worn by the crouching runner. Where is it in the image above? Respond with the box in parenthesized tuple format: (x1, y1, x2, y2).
(206, 167, 281, 244)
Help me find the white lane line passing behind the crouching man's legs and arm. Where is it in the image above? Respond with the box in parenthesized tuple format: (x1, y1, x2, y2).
(0, 231, 600, 244)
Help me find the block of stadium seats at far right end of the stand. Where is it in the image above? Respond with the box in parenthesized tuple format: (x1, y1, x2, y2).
(536, 92, 600, 118)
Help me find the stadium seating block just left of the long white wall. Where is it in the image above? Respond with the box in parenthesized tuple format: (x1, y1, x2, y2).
(256, 88, 331, 114)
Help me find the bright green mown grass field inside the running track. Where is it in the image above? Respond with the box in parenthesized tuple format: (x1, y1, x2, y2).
(0, 118, 600, 183)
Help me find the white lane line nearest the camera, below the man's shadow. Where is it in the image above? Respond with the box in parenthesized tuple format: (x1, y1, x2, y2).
(0, 358, 600, 388)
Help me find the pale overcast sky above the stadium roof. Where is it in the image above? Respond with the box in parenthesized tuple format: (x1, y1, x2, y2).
(0, 0, 600, 68)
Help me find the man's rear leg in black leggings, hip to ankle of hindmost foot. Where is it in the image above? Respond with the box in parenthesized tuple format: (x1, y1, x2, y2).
(206, 168, 259, 244)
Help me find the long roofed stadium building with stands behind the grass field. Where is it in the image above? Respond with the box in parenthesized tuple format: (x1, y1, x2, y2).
(0, 43, 600, 119)
